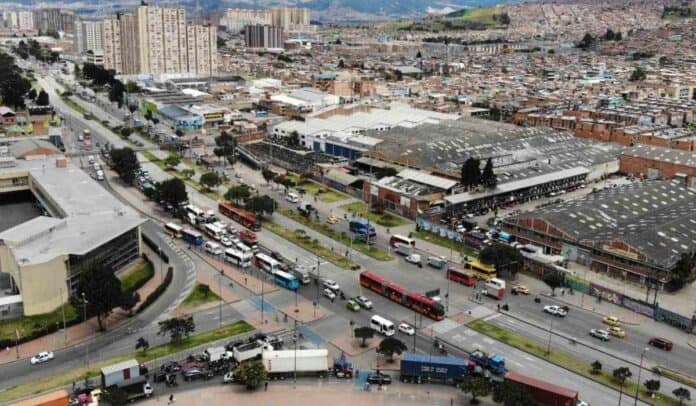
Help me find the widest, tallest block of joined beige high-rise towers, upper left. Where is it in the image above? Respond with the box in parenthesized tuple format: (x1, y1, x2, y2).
(103, 5, 217, 75)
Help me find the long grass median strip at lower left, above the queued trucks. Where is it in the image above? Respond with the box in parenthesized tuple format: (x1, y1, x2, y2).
(0, 320, 254, 403)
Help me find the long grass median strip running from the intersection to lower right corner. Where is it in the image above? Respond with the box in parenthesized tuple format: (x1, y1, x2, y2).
(467, 319, 680, 406)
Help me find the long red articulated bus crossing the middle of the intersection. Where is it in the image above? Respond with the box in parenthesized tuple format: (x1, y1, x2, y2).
(360, 271, 445, 320)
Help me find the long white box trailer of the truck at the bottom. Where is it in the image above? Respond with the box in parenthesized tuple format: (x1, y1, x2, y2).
(262, 349, 329, 379)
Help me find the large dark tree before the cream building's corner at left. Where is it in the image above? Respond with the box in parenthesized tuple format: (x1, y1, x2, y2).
(78, 261, 123, 331)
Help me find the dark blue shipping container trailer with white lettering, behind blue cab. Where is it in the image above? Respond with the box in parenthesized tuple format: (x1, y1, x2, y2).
(400, 352, 475, 385)
